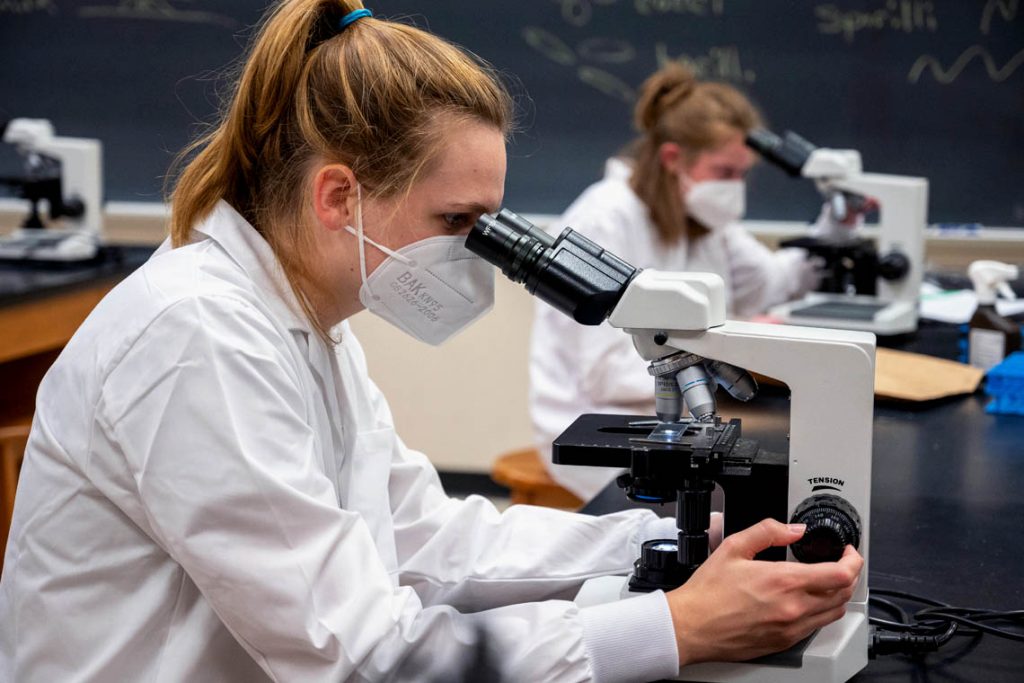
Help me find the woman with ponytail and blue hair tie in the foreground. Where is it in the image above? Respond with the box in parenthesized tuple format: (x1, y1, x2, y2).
(0, 0, 860, 683)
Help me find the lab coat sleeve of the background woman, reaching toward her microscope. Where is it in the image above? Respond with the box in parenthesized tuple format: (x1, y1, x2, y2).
(723, 224, 815, 316)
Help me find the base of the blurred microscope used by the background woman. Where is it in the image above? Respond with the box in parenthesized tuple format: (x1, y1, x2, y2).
(768, 293, 918, 336)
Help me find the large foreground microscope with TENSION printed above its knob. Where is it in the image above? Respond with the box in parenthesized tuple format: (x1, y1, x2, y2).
(466, 210, 874, 683)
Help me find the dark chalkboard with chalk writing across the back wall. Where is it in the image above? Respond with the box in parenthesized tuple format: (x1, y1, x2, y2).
(0, 0, 1024, 226)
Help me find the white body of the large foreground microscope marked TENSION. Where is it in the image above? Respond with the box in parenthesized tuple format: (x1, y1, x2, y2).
(577, 270, 874, 683)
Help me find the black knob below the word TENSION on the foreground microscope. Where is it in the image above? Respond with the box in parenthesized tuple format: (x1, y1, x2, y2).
(790, 494, 860, 563)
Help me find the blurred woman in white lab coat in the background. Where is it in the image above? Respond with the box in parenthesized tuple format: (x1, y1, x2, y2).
(529, 62, 818, 500)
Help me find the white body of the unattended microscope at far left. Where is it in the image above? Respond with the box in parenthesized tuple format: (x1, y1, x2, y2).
(0, 119, 103, 262)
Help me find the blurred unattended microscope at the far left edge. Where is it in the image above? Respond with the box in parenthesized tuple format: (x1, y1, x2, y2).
(0, 119, 102, 265)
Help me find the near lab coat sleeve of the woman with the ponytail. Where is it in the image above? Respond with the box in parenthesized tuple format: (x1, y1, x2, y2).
(87, 297, 678, 681)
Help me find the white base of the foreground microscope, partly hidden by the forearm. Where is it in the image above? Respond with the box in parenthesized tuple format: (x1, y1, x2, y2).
(575, 577, 868, 683)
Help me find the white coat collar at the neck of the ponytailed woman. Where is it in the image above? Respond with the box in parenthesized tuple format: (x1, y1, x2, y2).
(193, 200, 314, 335)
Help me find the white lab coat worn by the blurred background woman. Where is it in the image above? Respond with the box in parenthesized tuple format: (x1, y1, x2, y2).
(529, 159, 815, 500)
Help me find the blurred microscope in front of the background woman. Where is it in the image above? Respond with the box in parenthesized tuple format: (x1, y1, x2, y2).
(746, 129, 928, 335)
